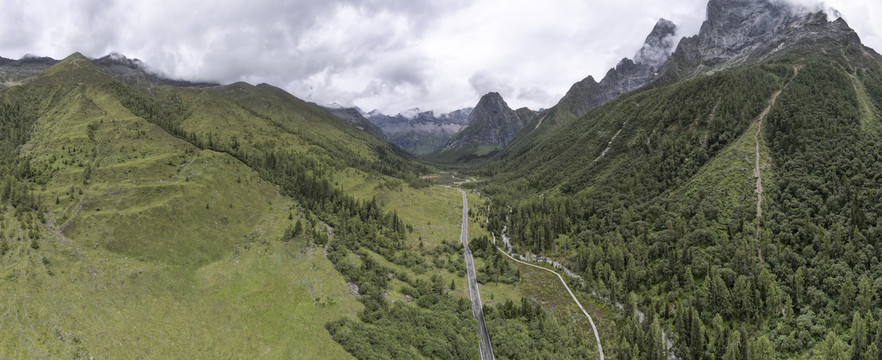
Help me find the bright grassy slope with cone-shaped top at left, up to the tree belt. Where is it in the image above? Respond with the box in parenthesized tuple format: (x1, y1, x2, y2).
(0, 55, 361, 358)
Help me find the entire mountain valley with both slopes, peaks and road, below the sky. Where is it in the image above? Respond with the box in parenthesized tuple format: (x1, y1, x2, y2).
(0, 0, 882, 360)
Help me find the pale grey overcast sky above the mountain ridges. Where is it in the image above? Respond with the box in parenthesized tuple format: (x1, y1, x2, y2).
(0, 0, 882, 114)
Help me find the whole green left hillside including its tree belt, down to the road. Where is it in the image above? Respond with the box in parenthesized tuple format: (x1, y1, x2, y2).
(0, 54, 594, 358)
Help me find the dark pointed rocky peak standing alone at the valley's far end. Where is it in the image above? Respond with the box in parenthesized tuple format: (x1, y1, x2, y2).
(443, 92, 536, 150)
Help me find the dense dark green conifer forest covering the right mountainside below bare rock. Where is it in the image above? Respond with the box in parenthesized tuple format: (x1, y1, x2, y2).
(477, 57, 882, 360)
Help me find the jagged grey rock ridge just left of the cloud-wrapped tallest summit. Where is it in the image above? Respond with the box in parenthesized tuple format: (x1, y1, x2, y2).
(558, 19, 677, 116)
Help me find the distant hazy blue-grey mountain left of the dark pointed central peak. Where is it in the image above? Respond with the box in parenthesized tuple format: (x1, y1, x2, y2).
(367, 108, 472, 155)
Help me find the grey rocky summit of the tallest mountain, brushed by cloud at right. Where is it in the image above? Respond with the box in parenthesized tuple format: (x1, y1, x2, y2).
(662, 0, 860, 82)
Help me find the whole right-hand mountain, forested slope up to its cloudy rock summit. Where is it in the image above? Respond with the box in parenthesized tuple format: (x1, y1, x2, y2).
(478, 0, 882, 359)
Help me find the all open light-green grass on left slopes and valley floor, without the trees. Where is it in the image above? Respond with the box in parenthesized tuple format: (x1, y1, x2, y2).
(0, 52, 592, 359)
